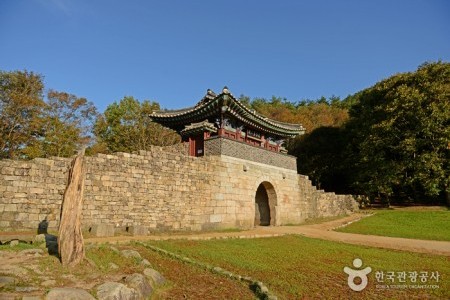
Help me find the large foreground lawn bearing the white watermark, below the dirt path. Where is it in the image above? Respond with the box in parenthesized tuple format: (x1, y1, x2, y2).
(150, 235, 450, 299)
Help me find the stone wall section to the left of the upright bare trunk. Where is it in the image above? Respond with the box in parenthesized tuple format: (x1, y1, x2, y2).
(0, 158, 71, 230)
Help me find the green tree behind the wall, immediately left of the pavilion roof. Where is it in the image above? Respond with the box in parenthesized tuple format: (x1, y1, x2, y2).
(94, 97, 180, 152)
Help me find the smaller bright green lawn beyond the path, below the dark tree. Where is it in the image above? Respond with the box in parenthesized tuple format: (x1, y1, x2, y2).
(337, 210, 450, 241)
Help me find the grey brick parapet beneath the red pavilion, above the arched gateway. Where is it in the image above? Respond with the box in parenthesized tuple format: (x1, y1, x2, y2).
(205, 137, 297, 170)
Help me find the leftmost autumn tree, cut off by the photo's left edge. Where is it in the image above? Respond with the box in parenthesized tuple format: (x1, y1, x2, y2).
(0, 71, 45, 159)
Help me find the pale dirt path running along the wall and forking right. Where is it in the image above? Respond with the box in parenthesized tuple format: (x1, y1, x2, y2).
(85, 213, 450, 256)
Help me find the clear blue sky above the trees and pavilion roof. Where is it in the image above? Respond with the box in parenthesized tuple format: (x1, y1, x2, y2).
(0, 0, 450, 111)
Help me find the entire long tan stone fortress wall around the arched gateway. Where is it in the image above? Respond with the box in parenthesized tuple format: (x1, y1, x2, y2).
(0, 147, 357, 231)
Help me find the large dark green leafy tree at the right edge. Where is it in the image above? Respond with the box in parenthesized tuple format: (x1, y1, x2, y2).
(347, 62, 450, 202)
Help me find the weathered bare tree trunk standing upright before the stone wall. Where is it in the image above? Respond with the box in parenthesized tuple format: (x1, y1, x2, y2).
(58, 150, 86, 266)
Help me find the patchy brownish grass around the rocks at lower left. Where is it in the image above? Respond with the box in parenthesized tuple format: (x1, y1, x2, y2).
(0, 243, 255, 300)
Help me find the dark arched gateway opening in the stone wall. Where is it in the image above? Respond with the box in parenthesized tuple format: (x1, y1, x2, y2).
(255, 181, 277, 226)
